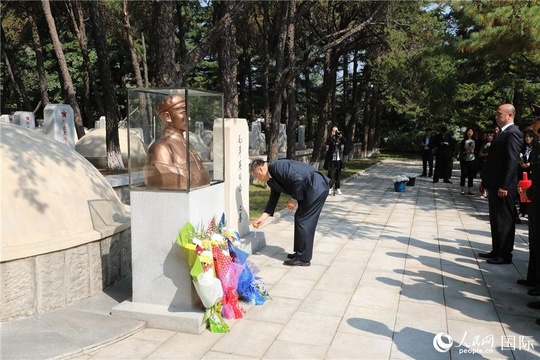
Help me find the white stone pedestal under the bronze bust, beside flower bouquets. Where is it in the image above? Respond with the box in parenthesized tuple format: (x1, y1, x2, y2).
(112, 183, 225, 334)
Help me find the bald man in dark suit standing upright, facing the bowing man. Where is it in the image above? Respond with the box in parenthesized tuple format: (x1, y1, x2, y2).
(478, 104, 523, 264)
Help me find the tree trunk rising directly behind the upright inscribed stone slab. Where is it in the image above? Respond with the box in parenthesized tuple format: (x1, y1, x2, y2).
(215, 1, 238, 118)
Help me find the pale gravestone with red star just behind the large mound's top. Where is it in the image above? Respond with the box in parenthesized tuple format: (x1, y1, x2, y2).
(43, 104, 77, 149)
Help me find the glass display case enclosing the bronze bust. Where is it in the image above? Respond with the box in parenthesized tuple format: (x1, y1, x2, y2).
(127, 88, 224, 192)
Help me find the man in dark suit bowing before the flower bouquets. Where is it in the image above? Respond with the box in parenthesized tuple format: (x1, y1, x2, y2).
(250, 160, 330, 266)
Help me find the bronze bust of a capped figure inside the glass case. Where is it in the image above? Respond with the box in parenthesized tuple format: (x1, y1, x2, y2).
(144, 94, 210, 190)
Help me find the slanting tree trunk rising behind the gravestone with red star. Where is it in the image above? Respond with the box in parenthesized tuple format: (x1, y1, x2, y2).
(41, 0, 84, 139)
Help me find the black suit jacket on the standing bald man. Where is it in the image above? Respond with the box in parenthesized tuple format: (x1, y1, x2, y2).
(482, 125, 523, 195)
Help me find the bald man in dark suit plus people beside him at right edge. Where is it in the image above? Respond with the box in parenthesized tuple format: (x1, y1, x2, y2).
(478, 104, 540, 325)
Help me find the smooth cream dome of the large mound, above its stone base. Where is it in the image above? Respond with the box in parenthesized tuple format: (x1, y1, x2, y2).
(0, 122, 131, 261)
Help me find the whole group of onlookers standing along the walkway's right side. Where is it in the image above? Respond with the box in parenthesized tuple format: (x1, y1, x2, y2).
(422, 104, 540, 325)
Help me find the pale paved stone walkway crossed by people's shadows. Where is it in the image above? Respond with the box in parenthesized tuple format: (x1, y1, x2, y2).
(0, 160, 540, 360)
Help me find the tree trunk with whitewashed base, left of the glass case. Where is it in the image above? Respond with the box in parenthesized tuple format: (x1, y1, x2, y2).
(88, 1, 124, 170)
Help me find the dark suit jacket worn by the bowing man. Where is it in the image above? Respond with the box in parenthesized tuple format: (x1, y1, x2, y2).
(264, 159, 330, 215)
